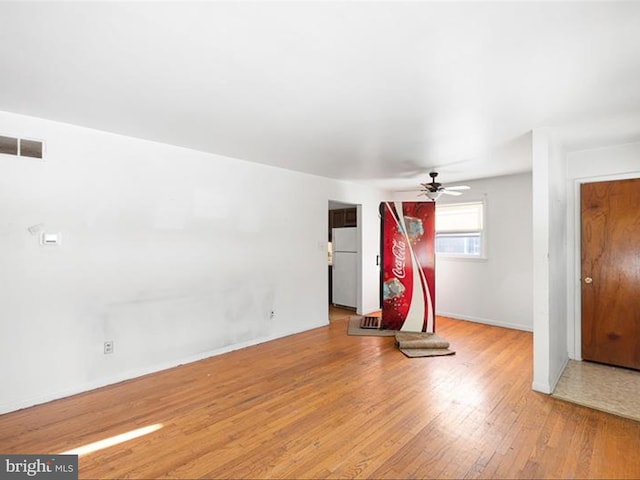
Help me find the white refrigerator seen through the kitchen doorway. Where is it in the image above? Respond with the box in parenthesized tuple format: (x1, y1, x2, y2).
(331, 228, 358, 308)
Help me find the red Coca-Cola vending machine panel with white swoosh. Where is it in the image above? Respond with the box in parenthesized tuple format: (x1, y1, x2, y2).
(380, 202, 436, 333)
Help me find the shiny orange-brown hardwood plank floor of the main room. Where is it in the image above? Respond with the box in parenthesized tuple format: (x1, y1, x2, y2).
(0, 315, 640, 478)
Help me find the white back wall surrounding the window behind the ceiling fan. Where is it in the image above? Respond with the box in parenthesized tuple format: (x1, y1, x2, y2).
(399, 173, 533, 331)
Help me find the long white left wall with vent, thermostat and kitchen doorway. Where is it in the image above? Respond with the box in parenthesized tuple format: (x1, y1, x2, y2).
(0, 112, 383, 413)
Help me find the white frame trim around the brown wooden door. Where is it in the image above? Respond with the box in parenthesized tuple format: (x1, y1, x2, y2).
(567, 172, 640, 360)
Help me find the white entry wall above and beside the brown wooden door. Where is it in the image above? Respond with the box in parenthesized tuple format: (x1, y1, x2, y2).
(566, 143, 640, 360)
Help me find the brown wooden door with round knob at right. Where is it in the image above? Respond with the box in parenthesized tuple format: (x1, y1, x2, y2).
(581, 178, 640, 370)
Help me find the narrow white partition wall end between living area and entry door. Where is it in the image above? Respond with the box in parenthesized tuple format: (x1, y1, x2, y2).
(532, 129, 568, 393)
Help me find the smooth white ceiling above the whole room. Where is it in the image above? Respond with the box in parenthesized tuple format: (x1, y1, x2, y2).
(0, 1, 640, 189)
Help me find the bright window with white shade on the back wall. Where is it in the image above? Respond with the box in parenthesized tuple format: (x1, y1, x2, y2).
(435, 202, 484, 258)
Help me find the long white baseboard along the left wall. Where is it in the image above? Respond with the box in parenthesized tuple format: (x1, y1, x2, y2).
(0, 322, 328, 415)
